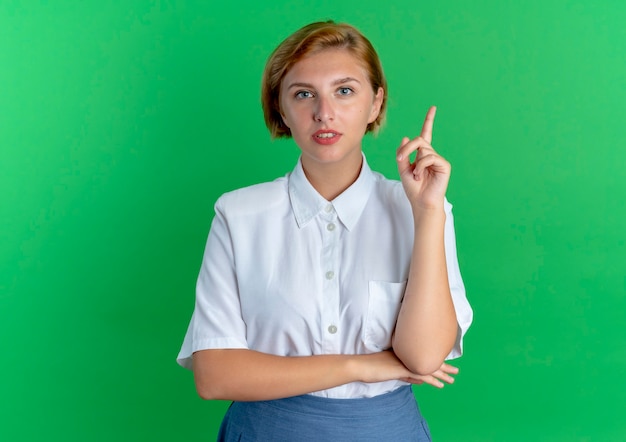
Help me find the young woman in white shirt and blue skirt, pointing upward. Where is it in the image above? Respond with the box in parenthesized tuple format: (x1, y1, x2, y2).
(178, 22, 472, 441)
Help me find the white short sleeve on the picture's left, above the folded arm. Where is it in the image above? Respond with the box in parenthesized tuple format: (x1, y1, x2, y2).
(176, 200, 247, 369)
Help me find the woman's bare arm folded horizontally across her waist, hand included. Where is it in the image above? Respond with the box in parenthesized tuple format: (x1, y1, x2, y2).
(193, 349, 448, 401)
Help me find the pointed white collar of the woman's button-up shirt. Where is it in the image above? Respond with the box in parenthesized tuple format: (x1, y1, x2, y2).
(289, 155, 374, 230)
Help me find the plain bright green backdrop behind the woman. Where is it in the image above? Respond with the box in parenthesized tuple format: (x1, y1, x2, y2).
(0, 0, 626, 442)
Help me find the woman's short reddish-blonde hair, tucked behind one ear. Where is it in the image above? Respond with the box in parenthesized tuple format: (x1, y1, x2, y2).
(261, 21, 387, 138)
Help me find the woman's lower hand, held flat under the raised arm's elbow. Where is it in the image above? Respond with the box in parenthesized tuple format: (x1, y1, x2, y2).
(361, 350, 459, 388)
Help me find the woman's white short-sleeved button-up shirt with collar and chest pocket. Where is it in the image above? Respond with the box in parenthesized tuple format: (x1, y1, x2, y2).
(177, 158, 472, 398)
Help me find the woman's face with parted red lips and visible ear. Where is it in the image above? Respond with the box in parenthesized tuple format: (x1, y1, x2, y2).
(279, 49, 383, 169)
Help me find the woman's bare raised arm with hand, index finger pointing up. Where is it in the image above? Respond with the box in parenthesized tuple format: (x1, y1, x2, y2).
(392, 107, 458, 375)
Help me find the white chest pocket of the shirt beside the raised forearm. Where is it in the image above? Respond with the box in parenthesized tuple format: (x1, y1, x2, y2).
(363, 281, 406, 351)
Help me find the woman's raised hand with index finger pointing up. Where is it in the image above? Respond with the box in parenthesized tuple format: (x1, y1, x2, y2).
(396, 106, 451, 209)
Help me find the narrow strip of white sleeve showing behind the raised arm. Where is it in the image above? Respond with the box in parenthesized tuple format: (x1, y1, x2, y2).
(444, 201, 473, 359)
